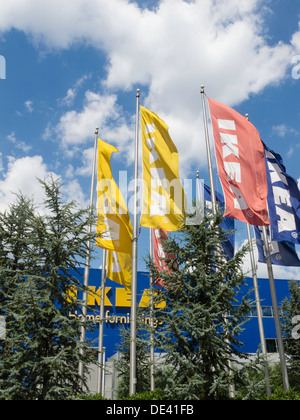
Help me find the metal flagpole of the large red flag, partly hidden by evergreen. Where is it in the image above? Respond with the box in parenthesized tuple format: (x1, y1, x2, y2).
(201, 85, 235, 398)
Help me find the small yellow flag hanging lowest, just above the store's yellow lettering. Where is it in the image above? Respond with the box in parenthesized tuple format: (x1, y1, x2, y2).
(106, 251, 132, 292)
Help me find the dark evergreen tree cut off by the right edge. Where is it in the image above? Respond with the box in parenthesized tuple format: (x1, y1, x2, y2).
(282, 281, 300, 391)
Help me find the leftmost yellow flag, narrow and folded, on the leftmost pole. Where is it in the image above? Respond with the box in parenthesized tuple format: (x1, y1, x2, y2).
(96, 139, 132, 253)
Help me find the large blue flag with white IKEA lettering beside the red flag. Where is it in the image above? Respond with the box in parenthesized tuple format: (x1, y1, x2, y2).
(264, 145, 300, 244)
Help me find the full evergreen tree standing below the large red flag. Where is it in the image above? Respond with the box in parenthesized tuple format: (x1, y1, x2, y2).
(149, 210, 250, 399)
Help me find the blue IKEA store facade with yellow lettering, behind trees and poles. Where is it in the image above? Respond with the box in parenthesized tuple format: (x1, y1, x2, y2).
(70, 269, 289, 359)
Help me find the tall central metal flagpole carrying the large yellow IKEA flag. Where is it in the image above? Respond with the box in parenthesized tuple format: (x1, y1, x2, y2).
(129, 89, 140, 395)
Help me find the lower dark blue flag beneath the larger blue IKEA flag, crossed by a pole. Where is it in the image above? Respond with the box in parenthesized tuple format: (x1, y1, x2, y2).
(255, 226, 300, 267)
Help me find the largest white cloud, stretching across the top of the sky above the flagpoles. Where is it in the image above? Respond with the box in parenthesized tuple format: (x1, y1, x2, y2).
(0, 0, 300, 104)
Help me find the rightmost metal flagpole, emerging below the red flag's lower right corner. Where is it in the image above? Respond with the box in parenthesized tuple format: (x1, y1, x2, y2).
(263, 226, 290, 391)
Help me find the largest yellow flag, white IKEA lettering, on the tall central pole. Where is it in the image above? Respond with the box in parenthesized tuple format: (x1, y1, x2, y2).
(140, 107, 186, 231)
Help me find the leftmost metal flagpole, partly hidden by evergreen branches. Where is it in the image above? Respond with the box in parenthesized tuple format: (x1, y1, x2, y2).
(78, 127, 99, 387)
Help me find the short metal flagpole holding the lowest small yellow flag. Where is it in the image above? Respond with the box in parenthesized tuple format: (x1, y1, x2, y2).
(97, 249, 107, 394)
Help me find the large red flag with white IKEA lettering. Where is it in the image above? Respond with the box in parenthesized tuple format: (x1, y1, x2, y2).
(208, 99, 270, 226)
